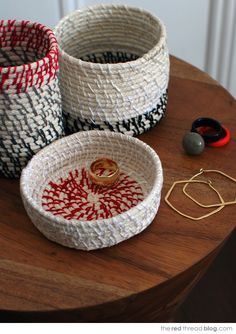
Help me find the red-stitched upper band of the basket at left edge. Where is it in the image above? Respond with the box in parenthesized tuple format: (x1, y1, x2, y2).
(0, 20, 59, 93)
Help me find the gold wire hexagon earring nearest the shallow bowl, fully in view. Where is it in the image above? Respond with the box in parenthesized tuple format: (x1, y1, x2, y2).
(165, 179, 224, 220)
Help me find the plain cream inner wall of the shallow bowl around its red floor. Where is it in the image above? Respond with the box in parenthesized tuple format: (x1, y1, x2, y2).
(24, 133, 157, 219)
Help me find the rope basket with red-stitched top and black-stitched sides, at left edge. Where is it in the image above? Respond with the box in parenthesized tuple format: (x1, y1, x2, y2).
(0, 20, 64, 177)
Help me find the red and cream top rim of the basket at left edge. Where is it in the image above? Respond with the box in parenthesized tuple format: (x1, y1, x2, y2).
(0, 20, 58, 74)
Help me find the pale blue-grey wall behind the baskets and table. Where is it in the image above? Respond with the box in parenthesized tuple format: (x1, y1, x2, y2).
(0, 0, 236, 97)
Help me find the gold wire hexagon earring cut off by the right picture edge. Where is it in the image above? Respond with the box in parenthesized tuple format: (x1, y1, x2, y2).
(183, 168, 236, 208)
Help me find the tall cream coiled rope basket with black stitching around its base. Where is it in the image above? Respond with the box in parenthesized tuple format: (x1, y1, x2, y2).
(55, 5, 169, 135)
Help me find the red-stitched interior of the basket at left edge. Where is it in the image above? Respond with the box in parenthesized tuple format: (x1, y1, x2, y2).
(0, 20, 50, 67)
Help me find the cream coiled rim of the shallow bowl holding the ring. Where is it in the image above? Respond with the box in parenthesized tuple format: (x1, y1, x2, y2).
(20, 130, 163, 226)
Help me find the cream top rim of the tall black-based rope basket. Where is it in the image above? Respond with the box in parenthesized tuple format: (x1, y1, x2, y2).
(53, 4, 167, 72)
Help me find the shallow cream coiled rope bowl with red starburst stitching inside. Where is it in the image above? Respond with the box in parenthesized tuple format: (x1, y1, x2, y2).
(20, 130, 163, 250)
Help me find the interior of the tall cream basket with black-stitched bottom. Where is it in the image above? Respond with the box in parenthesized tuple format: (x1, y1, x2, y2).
(57, 7, 162, 63)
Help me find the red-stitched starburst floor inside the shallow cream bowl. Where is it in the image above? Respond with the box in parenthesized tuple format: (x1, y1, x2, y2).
(42, 168, 144, 220)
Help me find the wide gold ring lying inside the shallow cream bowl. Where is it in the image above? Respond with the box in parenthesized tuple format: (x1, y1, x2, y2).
(89, 158, 120, 186)
